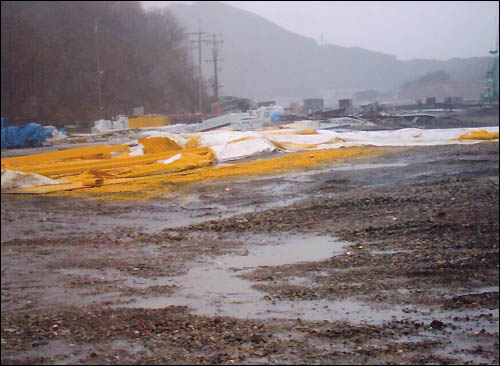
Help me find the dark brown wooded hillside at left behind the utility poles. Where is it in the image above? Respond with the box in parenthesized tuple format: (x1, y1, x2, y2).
(1, 1, 206, 125)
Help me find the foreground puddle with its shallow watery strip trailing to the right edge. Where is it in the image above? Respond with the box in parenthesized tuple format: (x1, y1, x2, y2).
(116, 236, 498, 332)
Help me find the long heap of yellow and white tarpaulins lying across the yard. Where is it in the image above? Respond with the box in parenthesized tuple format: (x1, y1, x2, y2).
(1, 124, 498, 199)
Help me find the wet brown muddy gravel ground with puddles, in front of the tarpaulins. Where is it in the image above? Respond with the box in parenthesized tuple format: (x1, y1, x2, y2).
(1, 142, 499, 365)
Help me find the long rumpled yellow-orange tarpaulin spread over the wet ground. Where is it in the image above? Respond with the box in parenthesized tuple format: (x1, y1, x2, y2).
(11, 148, 383, 199)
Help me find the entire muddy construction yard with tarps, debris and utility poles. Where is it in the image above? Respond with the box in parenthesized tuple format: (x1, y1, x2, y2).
(1, 2, 500, 365)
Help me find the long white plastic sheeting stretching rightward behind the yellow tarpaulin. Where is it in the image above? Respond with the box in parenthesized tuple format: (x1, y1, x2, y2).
(136, 127, 498, 162)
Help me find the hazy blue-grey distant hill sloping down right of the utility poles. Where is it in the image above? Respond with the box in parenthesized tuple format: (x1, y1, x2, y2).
(169, 2, 490, 105)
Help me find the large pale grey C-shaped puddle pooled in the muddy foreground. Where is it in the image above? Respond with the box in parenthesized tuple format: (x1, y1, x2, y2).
(118, 236, 348, 318)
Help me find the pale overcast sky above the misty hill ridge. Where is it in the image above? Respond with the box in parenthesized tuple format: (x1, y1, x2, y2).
(143, 1, 498, 60)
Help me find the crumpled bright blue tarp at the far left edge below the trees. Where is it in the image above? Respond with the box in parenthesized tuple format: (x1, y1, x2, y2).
(2, 123, 52, 149)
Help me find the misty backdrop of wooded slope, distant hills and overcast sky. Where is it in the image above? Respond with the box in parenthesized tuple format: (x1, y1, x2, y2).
(1, 1, 498, 125)
